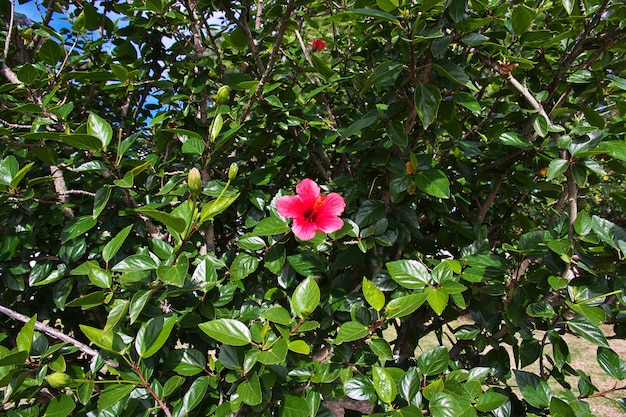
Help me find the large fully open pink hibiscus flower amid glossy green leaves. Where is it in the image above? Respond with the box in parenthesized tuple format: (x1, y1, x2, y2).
(276, 178, 346, 240)
